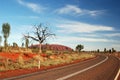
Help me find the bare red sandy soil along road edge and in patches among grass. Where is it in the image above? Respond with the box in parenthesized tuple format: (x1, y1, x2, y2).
(0, 53, 95, 79)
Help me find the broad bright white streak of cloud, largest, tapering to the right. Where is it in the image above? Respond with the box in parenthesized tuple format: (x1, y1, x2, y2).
(56, 20, 114, 33)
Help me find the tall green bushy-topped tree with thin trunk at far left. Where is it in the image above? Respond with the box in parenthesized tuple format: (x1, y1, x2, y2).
(2, 23, 10, 48)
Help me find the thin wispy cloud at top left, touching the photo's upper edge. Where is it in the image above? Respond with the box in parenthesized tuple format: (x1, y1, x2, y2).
(17, 0, 45, 13)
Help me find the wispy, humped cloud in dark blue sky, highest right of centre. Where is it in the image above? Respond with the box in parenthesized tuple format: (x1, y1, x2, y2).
(56, 5, 105, 16)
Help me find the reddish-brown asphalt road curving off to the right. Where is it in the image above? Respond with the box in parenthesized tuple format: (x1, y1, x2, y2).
(4, 56, 120, 80)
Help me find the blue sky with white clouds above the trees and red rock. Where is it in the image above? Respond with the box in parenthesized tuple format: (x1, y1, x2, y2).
(0, 0, 120, 50)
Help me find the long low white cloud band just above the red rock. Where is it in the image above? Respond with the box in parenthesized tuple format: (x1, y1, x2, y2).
(48, 36, 116, 46)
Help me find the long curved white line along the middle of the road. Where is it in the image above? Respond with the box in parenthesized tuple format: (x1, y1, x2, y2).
(56, 56, 108, 80)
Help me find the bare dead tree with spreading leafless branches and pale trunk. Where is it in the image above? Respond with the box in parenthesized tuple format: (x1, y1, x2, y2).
(24, 24, 55, 53)
